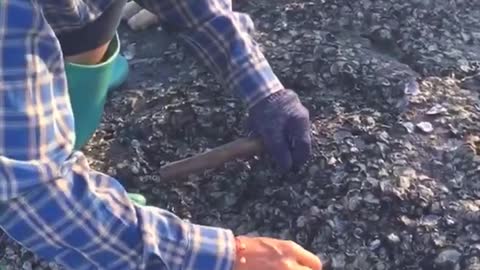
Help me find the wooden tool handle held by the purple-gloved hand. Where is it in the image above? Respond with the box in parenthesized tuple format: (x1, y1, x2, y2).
(160, 138, 263, 180)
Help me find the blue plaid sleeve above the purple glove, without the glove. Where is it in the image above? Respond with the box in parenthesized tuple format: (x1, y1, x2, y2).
(135, 0, 283, 106)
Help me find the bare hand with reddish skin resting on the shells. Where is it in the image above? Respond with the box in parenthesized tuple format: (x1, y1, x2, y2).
(234, 236, 322, 270)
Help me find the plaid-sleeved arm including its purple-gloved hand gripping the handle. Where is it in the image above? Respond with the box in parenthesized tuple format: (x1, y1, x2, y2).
(135, 0, 312, 173)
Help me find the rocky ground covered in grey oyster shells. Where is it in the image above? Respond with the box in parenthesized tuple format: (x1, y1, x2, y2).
(0, 0, 480, 270)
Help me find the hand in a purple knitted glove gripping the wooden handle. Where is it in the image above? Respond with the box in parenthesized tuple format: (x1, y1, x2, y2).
(248, 89, 311, 173)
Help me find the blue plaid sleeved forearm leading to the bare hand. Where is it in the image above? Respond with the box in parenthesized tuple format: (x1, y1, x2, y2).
(0, 160, 234, 270)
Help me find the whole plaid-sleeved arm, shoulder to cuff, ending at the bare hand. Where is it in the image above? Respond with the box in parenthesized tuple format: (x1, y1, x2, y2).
(0, 0, 234, 270)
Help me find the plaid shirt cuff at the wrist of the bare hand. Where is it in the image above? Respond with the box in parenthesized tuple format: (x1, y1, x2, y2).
(184, 221, 236, 270)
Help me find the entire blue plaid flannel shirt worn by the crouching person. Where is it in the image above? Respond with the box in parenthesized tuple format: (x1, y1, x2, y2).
(0, 0, 283, 270)
